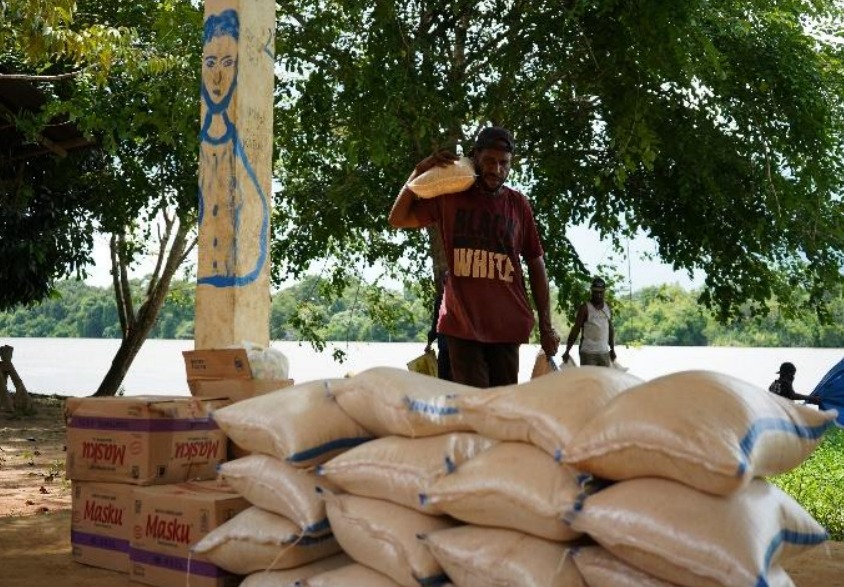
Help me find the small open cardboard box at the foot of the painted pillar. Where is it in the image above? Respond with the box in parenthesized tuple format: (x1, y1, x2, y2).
(182, 349, 293, 402)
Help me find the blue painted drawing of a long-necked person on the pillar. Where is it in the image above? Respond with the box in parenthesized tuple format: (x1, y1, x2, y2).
(197, 10, 269, 287)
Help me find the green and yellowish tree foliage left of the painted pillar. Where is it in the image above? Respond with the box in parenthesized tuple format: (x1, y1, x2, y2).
(0, 0, 202, 308)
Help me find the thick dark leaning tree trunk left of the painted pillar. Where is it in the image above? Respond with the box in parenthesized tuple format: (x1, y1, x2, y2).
(94, 218, 195, 397)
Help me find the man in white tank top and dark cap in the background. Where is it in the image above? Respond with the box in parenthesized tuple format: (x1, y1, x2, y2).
(563, 277, 615, 367)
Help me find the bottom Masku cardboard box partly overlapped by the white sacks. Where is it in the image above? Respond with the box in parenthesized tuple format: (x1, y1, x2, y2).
(129, 481, 250, 587)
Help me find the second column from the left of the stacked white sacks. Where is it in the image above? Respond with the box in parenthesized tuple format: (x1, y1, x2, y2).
(300, 367, 478, 587)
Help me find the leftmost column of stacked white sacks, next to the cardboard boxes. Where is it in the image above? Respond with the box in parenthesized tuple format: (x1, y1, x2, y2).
(192, 380, 372, 587)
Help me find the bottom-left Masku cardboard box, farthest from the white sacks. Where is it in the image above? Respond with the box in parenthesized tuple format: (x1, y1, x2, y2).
(70, 481, 134, 573)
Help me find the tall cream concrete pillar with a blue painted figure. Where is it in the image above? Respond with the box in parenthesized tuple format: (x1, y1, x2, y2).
(195, 0, 275, 349)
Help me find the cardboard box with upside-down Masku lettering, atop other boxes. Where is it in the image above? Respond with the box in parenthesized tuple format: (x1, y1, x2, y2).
(65, 396, 230, 485)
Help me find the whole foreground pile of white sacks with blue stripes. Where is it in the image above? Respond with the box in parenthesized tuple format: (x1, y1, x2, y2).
(199, 367, 834, 587)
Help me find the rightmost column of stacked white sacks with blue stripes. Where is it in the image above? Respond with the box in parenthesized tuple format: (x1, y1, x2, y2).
(562, 371, 835, 587)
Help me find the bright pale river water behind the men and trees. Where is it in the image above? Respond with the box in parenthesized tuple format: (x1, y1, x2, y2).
(0, 337, 844, 396)
